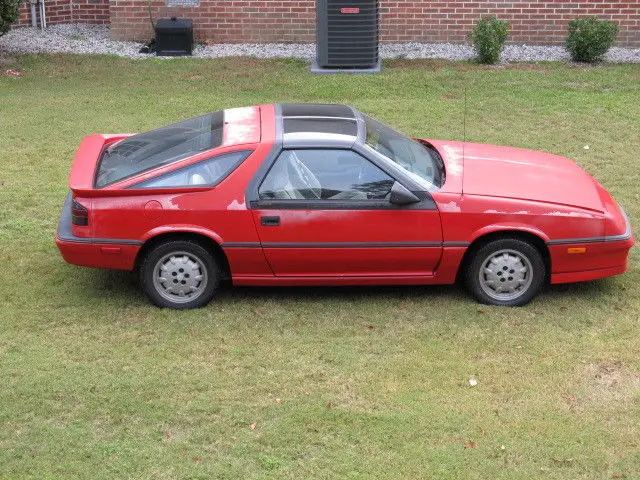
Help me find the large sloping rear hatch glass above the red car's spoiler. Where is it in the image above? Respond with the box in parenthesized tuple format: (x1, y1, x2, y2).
(95, 111, 224, 188)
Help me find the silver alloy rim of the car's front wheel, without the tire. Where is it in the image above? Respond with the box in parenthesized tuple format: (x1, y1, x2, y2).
(478, 249, 533, 301)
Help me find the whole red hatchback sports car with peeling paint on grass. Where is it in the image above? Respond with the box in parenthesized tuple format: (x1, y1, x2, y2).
(56, 104, 634, 308)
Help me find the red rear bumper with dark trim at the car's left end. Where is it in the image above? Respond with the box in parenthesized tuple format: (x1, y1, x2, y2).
(55, 192, 142, 270)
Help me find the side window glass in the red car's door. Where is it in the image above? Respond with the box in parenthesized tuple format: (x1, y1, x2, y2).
(258, 149, 394, 200)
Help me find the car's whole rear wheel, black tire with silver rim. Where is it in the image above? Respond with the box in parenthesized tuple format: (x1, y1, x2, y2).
(140, 240, 220, 310)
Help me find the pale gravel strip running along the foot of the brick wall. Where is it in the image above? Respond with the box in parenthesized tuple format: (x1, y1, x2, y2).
(0, 24, 640, 63)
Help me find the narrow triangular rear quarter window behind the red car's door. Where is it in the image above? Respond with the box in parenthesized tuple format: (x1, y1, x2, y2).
(129, 150, 251, 188)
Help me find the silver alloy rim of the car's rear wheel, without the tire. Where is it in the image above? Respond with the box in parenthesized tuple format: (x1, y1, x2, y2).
(153, 251, 209, 303)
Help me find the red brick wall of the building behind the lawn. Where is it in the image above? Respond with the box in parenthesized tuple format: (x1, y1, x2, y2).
(13, 0, 640, 47)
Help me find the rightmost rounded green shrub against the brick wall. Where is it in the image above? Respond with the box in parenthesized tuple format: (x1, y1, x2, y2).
(566, 17, 619, 62)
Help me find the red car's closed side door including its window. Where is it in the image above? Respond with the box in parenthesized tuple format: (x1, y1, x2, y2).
(251, 148, 442, 277)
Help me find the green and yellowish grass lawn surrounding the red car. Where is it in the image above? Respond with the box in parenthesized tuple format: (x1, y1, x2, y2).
(0, 56, 640, 479)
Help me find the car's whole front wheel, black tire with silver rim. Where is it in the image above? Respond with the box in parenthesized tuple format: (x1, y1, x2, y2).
(465, 238, 547, 307)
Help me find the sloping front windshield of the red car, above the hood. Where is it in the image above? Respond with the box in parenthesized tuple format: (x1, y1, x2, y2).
(362, 114, 444, 190)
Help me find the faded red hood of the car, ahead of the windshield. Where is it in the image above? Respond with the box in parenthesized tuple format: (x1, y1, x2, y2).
(433, 141, 604, 212)
